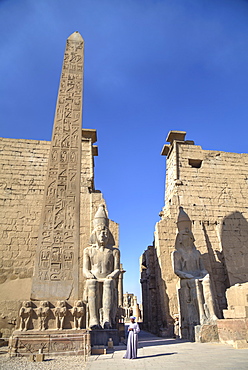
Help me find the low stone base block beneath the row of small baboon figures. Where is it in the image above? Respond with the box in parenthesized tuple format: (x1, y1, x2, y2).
(9, 329, 91, 358)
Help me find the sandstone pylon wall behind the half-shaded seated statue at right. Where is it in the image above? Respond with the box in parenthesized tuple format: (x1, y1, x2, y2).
(141, 132, 248, 336)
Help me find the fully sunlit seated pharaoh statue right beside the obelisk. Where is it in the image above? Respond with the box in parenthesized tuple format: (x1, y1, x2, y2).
(83, 205, 120, 329)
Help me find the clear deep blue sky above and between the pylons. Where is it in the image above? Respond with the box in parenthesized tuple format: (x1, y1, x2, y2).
(0, 0, 248, 302)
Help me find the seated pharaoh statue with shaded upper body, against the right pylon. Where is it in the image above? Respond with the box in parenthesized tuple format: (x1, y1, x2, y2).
(172, 207, 217, 340)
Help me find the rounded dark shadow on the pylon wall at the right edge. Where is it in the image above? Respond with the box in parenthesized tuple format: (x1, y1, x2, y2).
(221, 212, 248, 286)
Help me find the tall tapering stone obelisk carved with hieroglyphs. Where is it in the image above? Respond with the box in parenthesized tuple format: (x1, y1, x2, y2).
(31, 32, 84, 300)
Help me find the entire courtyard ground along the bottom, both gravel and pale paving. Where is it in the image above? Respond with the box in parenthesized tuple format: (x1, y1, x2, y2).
(0, 331, 248, 370)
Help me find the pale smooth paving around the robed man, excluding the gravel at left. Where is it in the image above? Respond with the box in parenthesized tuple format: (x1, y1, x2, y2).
(86, 331, 248, 370)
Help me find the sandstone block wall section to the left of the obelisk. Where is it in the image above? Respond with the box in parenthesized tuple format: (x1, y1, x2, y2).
(0, 138, 50, 337)
